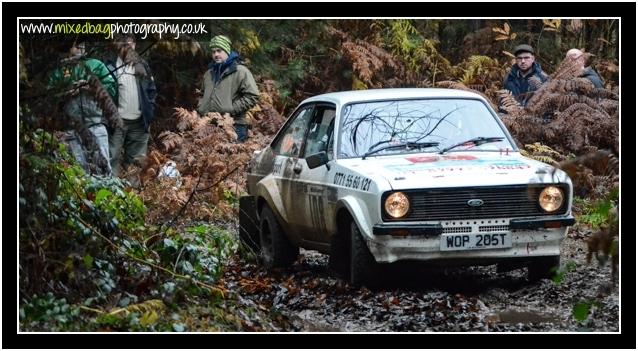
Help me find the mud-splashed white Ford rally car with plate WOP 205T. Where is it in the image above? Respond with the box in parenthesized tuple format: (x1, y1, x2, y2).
(240, 89, 574, 285)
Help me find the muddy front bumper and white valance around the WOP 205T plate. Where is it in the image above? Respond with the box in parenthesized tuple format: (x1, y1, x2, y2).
(368, 216, 575, 265)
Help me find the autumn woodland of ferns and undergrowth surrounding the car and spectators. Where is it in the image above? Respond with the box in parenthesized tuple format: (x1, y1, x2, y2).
(19, 19, 620, 331)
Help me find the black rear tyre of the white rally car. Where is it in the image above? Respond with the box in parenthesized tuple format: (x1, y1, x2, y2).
(259, 206, 299, 269)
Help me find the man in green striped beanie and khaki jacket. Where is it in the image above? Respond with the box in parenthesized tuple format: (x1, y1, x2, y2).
(197, 35, 259, 142)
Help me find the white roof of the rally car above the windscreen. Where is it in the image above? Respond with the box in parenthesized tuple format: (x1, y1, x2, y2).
(302, 88, 484, 105)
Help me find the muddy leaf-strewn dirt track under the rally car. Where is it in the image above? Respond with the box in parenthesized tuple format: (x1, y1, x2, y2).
(224, 230, 619, 332)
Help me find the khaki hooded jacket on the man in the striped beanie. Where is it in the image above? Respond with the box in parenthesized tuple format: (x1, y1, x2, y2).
(197, 51, 259, 125)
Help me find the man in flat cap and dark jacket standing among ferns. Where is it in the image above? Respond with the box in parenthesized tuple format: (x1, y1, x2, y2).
(503, 44, 547, 106)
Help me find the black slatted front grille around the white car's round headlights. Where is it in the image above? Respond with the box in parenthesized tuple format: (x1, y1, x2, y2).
(381, 184, 569, 222)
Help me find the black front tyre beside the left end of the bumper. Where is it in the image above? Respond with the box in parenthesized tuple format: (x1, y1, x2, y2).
(350, 221, 378, 289)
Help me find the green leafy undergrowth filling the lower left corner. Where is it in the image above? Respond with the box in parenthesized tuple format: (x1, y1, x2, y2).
(19, 124, 238, 330)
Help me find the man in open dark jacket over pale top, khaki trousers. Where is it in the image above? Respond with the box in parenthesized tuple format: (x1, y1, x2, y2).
(105, 35, 157, 176)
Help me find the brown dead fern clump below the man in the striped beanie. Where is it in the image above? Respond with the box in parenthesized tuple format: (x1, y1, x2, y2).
(142, 105, 280, 223)
